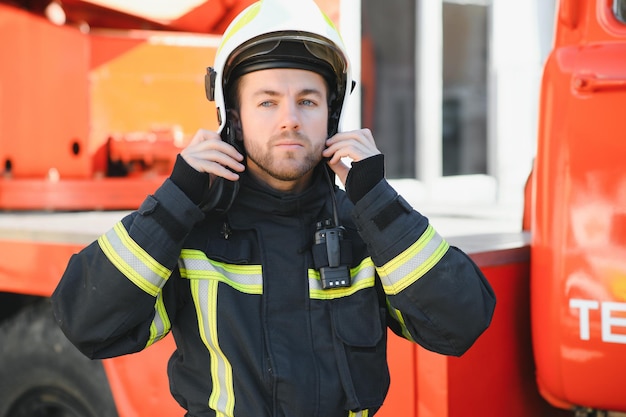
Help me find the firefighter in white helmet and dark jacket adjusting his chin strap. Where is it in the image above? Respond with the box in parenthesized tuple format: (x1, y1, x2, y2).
(52, 0, 495, 417)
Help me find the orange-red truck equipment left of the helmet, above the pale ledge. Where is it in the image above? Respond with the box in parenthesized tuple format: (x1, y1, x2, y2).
(0, 1, 227, 210)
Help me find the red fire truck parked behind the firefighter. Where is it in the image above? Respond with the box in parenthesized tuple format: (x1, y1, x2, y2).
(0, 0, 626, 417)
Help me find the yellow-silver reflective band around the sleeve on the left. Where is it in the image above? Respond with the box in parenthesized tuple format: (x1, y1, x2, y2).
(98, 222, 172, 297)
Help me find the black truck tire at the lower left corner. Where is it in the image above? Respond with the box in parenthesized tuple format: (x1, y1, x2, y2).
(0, 301, 118, 417)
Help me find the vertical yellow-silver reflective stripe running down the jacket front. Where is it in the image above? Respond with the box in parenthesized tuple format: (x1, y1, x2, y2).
(190, 280, 235, 417)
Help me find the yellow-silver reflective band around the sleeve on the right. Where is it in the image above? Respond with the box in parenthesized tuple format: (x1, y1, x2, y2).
(378, 225, 449, 294)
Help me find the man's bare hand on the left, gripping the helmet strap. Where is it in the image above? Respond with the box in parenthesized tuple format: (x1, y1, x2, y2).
(180, 129, 246, 181)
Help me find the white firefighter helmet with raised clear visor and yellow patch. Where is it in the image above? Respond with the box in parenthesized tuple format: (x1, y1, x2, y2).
(206, 0, 353, 135)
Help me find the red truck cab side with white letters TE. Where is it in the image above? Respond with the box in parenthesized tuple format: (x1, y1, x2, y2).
(531, 0, 626, 411)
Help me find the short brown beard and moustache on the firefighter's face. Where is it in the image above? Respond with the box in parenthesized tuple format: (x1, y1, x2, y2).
(244, 131, 324, 181)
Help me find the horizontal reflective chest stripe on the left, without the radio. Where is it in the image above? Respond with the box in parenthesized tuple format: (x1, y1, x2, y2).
(179, 249, 263, 295)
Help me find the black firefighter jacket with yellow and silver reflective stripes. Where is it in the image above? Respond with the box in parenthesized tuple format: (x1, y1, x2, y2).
(52, 167, 495, 417)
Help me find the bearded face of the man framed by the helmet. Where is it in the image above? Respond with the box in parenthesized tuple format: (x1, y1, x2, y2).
(239, 68, 328, 191)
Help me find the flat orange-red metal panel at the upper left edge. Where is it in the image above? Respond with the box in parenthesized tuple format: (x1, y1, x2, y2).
(0, 4, 91, 178)
